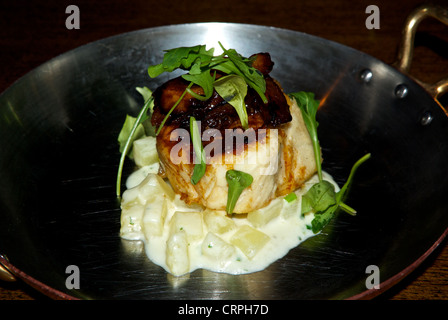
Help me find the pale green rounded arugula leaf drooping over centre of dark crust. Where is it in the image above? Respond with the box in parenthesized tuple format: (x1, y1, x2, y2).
(214, 74, 249, 130)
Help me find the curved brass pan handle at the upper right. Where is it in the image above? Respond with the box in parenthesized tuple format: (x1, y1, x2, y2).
(394, 5, 448, 104)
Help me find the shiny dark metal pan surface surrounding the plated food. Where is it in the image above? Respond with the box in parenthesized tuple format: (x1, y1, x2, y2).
(0, 23, 448, 299)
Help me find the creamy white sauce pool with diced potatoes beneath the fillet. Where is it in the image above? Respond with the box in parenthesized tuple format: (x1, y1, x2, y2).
(120, 164, 339, 275)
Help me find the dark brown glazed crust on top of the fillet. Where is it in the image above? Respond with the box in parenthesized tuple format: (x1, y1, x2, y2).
(151, 53, 291, 138)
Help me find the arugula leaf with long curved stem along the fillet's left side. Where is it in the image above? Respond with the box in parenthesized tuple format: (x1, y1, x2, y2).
(116, 89, 154, 197)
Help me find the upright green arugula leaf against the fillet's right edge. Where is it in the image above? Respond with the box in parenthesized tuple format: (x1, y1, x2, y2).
(290, 91, 322, 181)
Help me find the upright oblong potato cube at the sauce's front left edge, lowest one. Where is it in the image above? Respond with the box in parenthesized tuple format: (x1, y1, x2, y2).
(165, 231, 190, 276)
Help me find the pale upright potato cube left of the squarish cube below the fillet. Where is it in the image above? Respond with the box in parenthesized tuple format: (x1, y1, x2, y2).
(142, 197, 167, 239)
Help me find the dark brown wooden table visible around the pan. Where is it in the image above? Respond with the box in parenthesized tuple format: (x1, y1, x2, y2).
(0, 0, 448, 300)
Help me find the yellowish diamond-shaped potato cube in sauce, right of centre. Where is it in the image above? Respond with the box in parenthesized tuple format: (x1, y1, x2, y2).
(230, 225, 270, 259)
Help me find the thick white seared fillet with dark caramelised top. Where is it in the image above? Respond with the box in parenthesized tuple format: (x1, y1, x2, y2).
(152, 53, 316, 213)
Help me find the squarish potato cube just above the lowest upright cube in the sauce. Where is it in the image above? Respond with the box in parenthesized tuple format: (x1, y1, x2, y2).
(170, 211, 204, 241)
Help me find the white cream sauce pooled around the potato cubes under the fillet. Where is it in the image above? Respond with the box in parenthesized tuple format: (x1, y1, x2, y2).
(120, 164, 339, 275)
